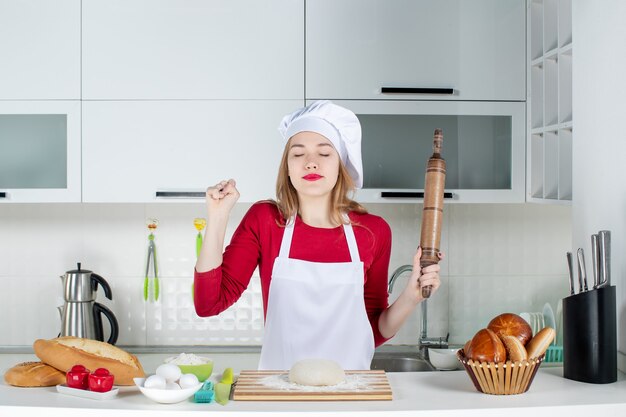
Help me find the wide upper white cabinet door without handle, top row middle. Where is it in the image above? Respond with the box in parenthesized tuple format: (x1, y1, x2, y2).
(82, 0, 304, 100)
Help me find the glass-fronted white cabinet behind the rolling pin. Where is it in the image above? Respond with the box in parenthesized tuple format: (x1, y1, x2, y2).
(335, 100, 526, 203)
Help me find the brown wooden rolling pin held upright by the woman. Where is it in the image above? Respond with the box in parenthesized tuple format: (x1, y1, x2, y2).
(420, 129, 446, 298)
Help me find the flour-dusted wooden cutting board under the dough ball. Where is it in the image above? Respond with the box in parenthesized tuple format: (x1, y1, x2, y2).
(233, 370, 392, 401)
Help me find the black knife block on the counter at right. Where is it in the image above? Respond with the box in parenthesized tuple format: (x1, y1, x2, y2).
(563, 286, 617, 384)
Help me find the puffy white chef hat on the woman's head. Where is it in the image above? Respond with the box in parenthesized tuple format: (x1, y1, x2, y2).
(278, 100, 363, 188)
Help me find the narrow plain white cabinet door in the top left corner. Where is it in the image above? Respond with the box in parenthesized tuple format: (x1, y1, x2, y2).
(0, 0, 80, 100)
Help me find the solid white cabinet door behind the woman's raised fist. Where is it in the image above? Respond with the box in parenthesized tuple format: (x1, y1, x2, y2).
(83, 100, 303, 203)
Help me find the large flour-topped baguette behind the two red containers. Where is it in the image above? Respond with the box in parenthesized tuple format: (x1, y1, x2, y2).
(33, 336, 145, 385)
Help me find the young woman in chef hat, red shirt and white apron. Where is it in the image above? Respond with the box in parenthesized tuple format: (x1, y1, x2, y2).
(194, 101, 440, 369)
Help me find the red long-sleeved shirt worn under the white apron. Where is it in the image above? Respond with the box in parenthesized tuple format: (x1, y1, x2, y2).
(194, 202, 391, 346)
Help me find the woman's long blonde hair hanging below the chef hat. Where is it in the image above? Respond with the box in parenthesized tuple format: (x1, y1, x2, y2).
(274, 139, 367, 225)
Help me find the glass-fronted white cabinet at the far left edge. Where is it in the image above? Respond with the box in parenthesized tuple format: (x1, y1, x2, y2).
(0, 100, 81, 203)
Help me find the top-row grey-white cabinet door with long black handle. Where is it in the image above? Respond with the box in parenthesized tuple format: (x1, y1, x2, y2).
(306, 0, 526, 101)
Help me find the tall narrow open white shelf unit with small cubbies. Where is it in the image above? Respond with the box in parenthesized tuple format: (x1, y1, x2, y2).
(526, 0, 573, 204)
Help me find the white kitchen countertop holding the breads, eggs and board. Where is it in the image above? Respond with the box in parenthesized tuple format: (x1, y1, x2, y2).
(0, 352, 626, 417)
